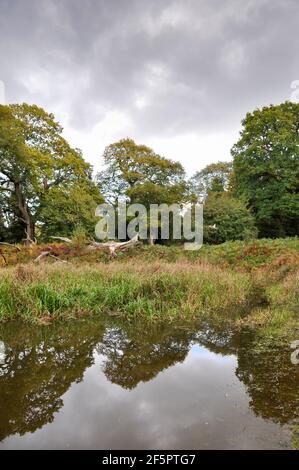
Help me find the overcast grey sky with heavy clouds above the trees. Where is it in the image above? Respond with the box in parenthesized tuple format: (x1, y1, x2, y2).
(0, 0, 299, 174)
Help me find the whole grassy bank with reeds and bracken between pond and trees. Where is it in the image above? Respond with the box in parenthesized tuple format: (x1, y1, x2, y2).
(0, 239, 299, 334)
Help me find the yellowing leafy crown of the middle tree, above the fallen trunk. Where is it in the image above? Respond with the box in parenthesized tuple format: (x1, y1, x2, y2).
(98, 139, 186, 207)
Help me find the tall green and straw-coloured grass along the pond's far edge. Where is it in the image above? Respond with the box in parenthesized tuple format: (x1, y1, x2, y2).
(0, 262, 252, 320)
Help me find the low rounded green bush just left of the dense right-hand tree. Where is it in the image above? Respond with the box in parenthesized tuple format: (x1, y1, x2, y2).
(204, 191, 257, 244)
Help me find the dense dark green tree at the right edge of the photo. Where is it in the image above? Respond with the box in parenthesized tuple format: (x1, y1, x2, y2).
(232, 102, 299, 237)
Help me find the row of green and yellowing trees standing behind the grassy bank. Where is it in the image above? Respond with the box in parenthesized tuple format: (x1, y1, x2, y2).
(0, 102, 299, 243)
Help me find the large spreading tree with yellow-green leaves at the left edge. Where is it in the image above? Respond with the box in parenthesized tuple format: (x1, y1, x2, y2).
(0, 104, 100, 239)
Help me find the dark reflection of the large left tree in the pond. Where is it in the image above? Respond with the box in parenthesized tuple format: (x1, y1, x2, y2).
(0, 322, 103, 440)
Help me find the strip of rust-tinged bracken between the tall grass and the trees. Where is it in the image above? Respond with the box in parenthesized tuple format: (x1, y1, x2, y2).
(0, 238, 299, 272)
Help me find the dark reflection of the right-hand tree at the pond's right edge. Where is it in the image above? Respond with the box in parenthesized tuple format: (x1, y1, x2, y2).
(197, 325, 299, 424)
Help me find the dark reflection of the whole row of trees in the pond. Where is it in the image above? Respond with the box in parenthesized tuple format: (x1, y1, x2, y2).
(0, 319, 299, 440)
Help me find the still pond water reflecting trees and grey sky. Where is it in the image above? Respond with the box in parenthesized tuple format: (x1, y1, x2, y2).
(0, 318, 299, 449)
